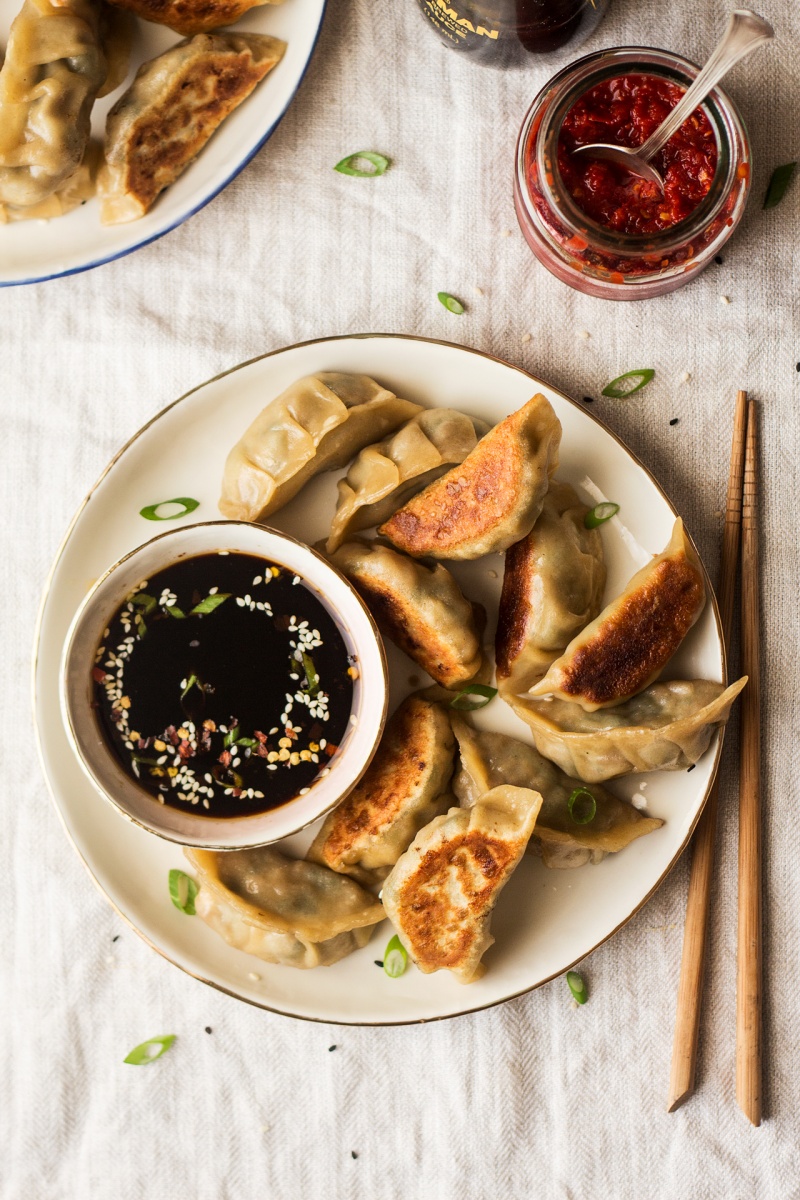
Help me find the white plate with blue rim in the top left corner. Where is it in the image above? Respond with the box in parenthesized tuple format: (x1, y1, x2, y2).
(0, 0, 333, 287)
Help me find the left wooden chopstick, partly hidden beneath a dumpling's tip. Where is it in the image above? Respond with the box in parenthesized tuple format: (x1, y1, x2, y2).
(667, 391, 747, 1112)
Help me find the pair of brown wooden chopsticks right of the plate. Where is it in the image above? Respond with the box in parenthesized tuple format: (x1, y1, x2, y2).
(667, 391, 762, 1126)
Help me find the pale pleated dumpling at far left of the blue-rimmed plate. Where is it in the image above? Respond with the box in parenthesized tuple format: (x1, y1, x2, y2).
(0, 0, 108, 211)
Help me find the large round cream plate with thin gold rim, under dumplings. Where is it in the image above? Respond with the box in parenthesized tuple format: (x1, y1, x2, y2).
(35, 335, 724, 1025)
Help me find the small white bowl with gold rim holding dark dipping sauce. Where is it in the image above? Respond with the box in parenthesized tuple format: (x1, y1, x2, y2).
(61, 521, 387, 850)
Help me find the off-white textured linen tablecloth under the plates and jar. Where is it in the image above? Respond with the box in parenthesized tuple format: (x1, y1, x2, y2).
(0, 0, 800, 1200)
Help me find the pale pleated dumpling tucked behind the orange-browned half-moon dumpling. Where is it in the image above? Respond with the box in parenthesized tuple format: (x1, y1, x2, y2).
(327, 408, 489, 553)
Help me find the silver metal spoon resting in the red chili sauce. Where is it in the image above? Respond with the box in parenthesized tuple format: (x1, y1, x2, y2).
(572, 8, 775, 192)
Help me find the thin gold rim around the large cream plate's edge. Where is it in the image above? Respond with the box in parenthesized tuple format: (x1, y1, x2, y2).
(31, 334, 728, 1028)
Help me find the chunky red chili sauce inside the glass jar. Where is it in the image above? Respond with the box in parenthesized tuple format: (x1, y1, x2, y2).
(558, 74, 717, 235)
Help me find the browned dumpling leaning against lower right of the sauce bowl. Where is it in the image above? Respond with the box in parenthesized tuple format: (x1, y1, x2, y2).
(307, 696, 455, 884)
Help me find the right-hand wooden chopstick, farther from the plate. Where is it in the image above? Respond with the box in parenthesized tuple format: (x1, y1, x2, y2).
(736, 400, 762, 1126)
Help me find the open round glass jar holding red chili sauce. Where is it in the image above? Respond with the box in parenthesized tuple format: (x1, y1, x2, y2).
(515, 47, 751, 300)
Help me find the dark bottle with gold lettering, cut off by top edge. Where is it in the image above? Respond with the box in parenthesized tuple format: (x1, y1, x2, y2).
(416, 0, 608, 67)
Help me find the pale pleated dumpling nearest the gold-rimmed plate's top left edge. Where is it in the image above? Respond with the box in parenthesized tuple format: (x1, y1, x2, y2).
(219, 371, 421, 521)
